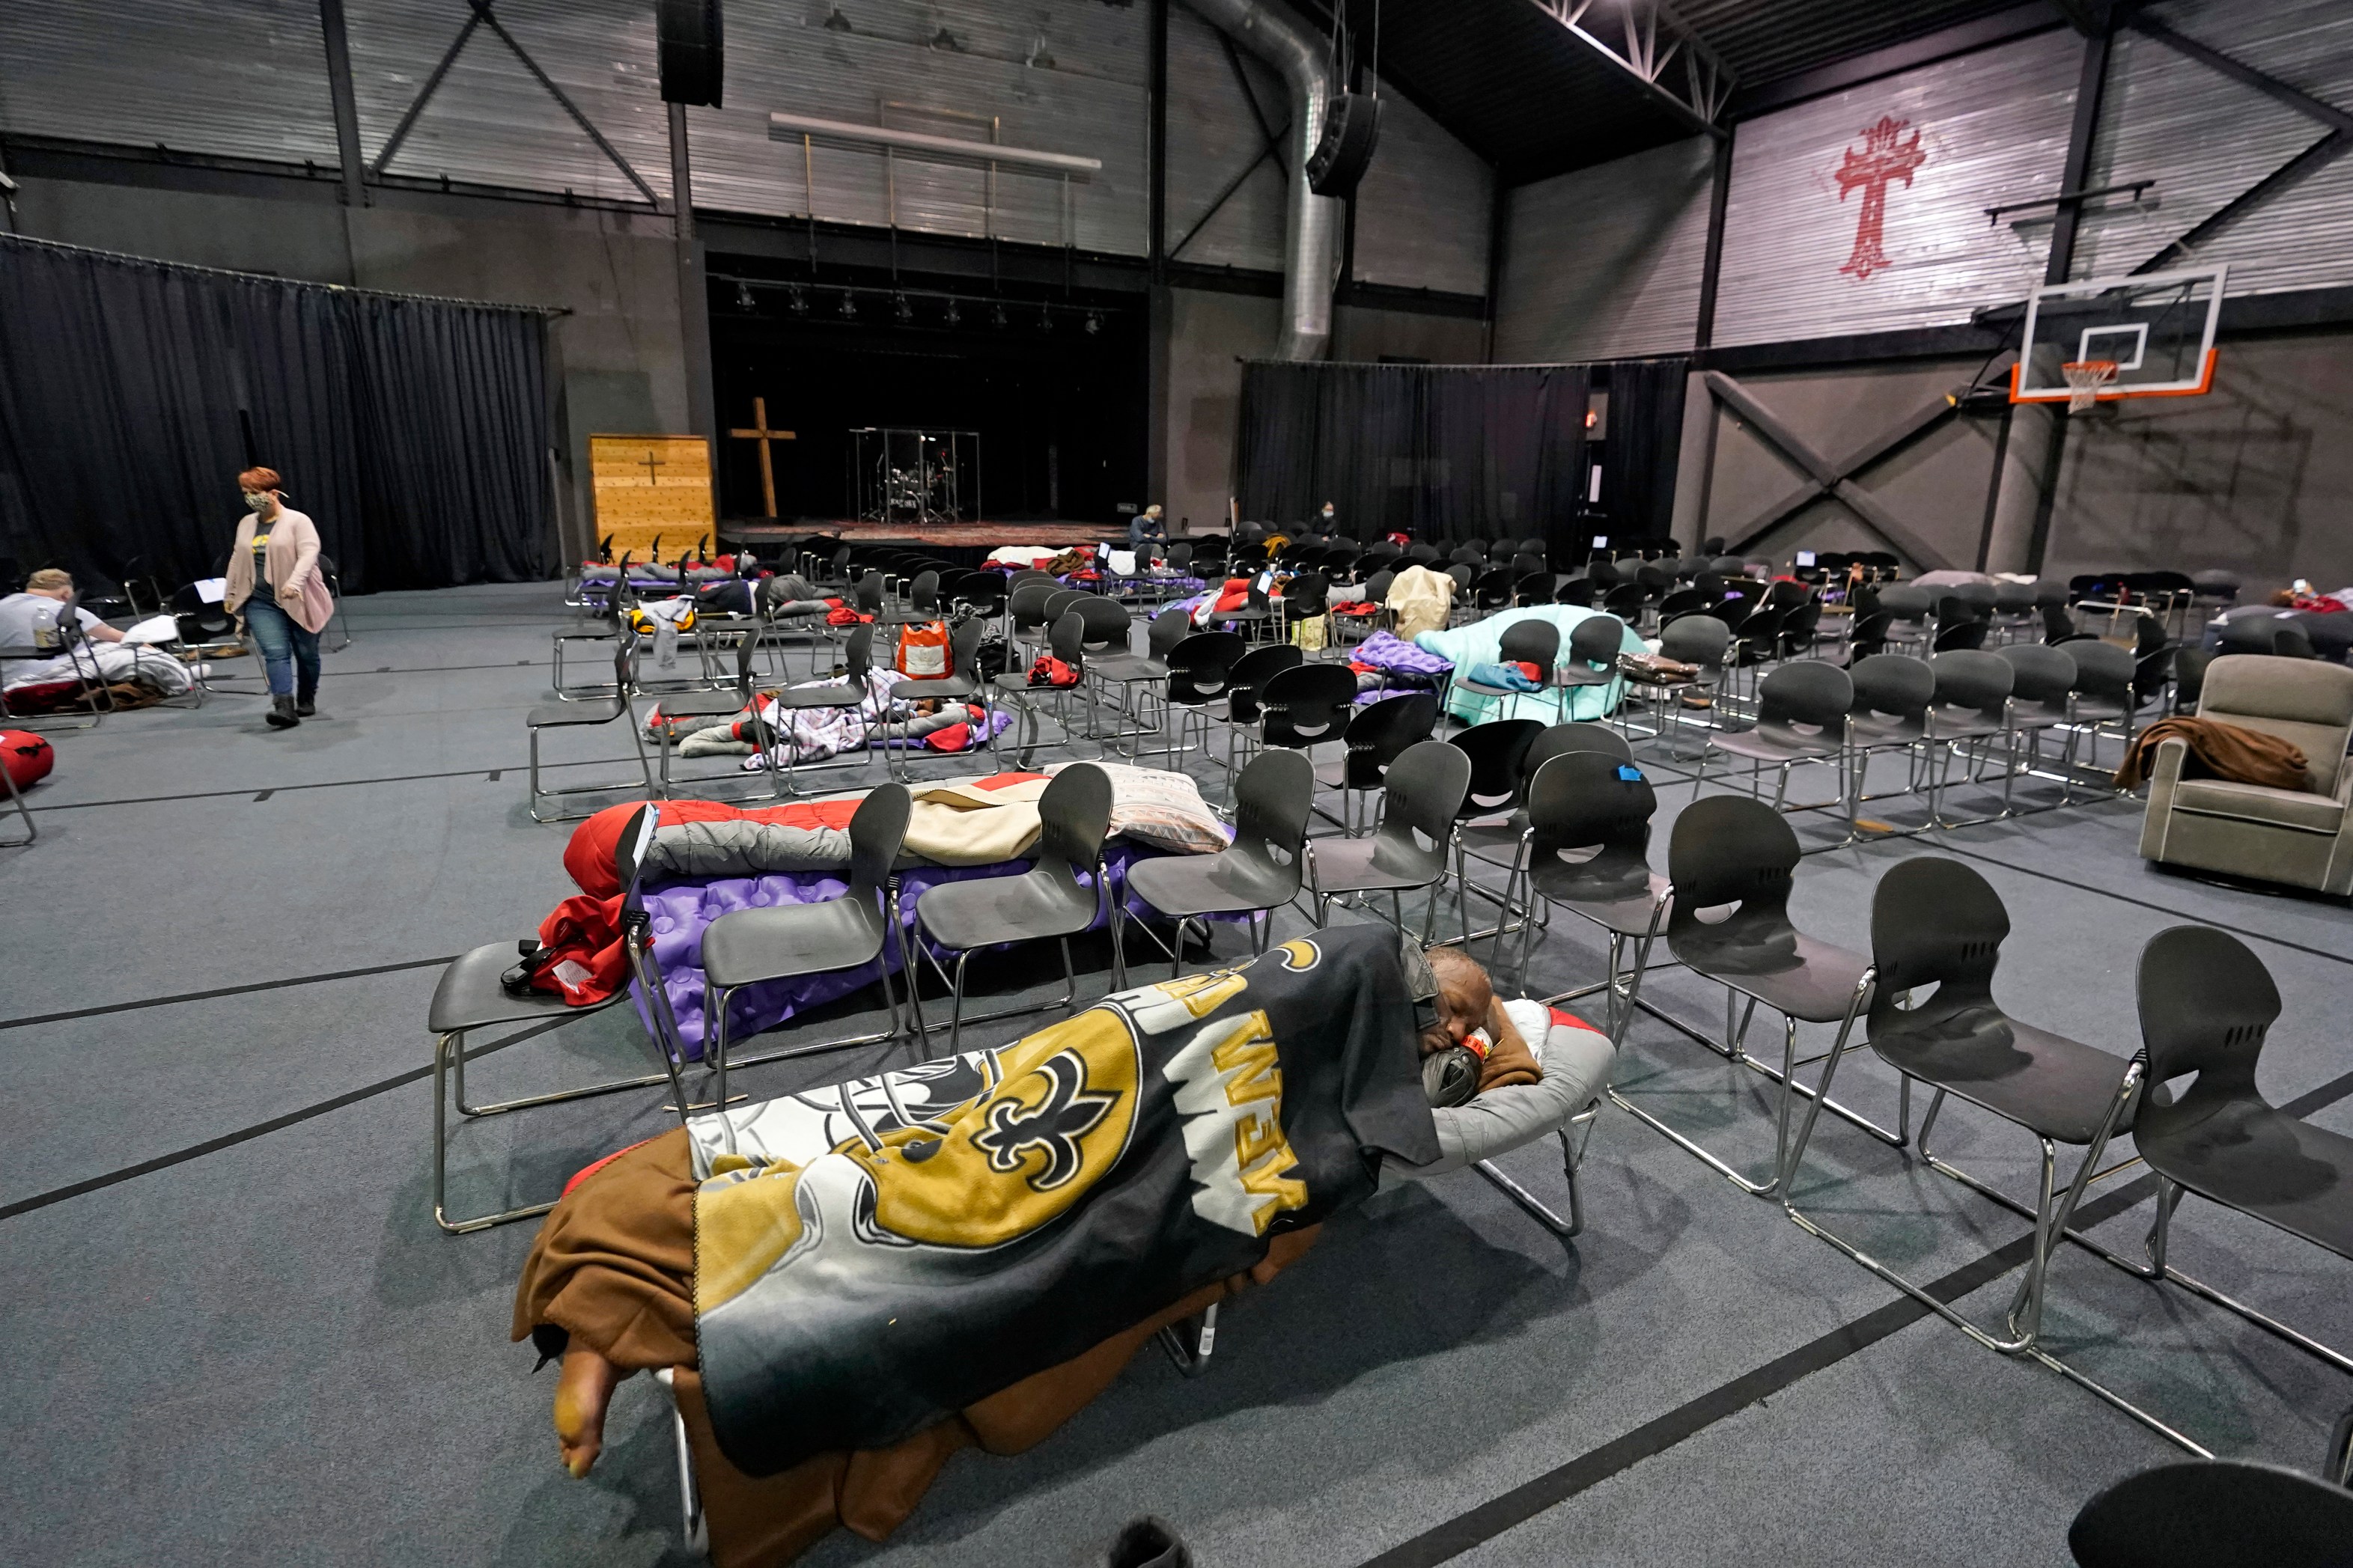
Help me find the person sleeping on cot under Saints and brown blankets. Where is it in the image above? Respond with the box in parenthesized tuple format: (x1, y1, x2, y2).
(513, 924, 1607, 1568)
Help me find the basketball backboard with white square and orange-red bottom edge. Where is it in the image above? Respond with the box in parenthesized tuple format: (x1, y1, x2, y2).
(2009, 266, 2228, 402)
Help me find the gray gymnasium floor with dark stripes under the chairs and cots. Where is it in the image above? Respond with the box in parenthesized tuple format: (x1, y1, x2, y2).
(0, 585, 2353, 1568)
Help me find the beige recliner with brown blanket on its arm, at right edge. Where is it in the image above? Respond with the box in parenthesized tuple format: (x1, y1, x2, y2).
(2141, 653, 2353, 894)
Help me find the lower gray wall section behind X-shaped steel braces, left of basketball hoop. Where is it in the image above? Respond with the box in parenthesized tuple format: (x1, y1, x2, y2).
(1684, 360, 2000, 569)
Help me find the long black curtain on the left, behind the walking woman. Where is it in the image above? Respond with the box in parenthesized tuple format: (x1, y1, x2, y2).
(0, 235, 555, 593)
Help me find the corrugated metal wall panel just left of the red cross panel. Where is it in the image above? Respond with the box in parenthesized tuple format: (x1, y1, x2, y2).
(1494, 136, 1715, 364)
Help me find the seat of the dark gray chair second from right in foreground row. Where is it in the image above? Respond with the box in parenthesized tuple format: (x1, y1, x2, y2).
(1871, 1001, 2125, 1145)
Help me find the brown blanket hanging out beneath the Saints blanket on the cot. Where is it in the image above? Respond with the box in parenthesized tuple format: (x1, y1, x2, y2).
(513, 1129, 1320, 1568)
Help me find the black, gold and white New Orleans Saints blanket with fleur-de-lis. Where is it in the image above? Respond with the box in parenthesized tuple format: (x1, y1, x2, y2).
(692, 927, 1437, 1477)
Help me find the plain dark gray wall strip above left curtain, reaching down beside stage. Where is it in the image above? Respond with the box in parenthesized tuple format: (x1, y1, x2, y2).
(16, 179, 687, 564)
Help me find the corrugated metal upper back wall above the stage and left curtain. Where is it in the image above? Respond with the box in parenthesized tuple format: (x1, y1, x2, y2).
(0, 0, 1492, 294)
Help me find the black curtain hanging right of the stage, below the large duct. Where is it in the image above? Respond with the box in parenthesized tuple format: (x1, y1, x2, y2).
(1235, 360, 1589, 560)
